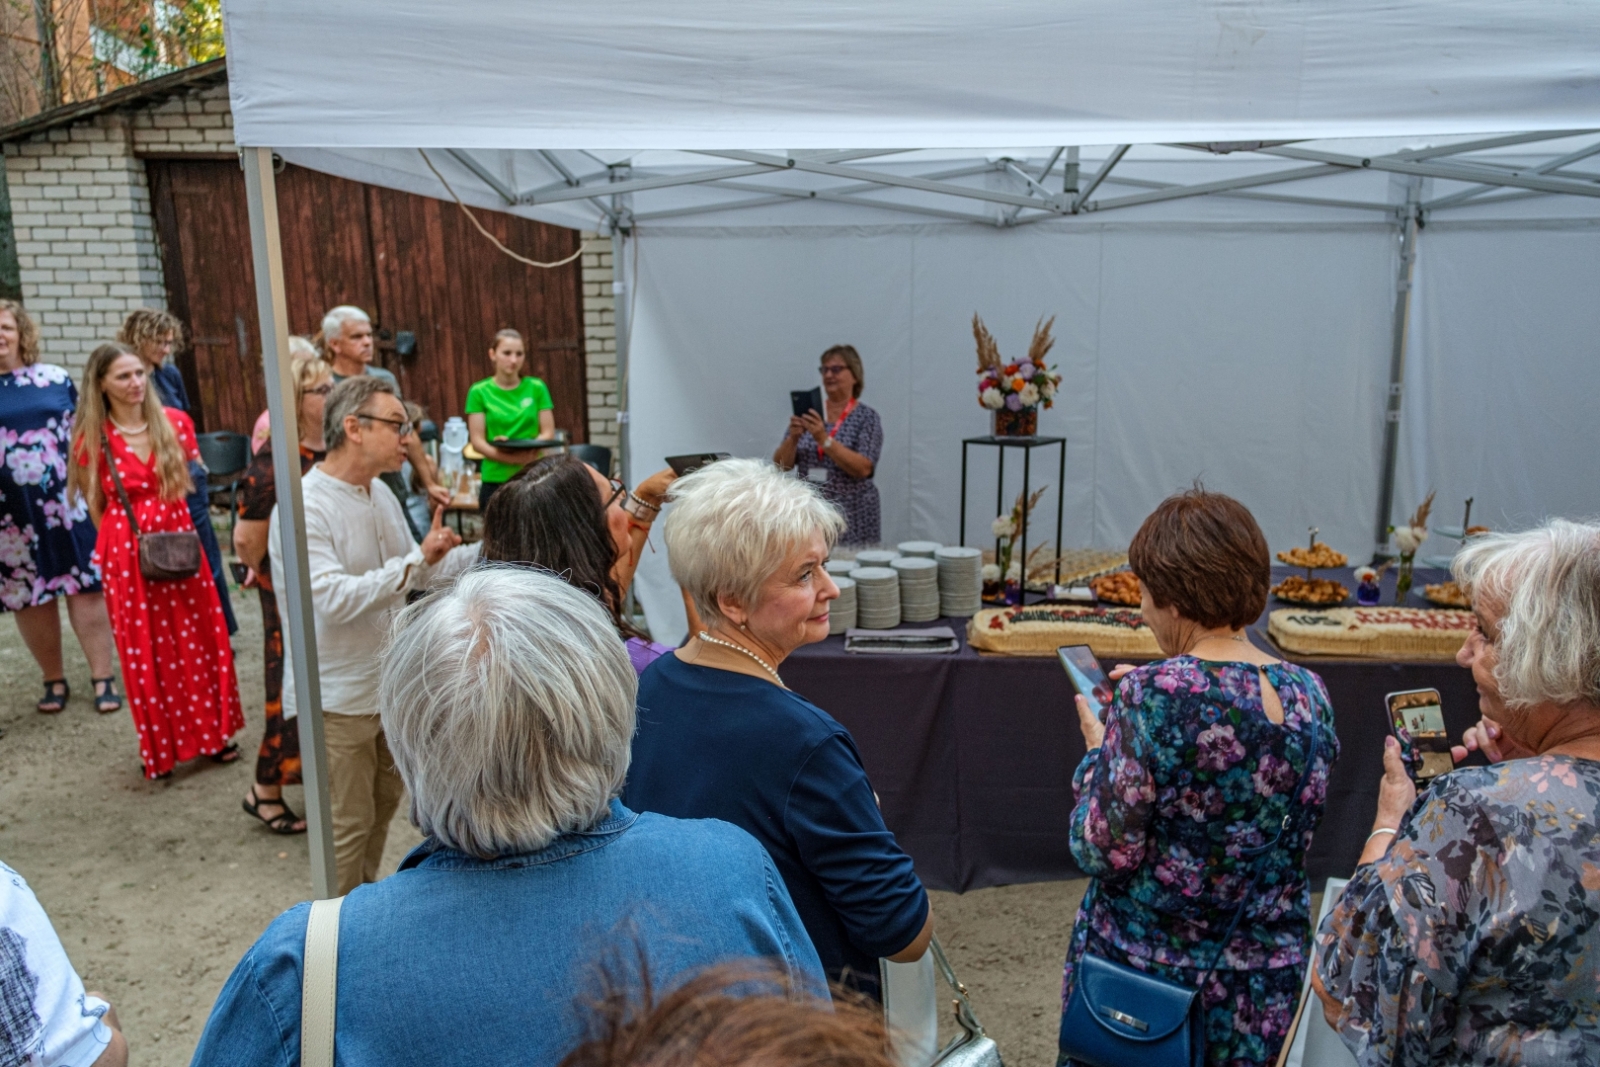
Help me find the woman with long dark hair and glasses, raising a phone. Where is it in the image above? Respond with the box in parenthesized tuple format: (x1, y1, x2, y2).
(480, 454, 678, 673)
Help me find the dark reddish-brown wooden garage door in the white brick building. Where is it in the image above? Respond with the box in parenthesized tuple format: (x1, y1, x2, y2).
(146, 160, 587, 442)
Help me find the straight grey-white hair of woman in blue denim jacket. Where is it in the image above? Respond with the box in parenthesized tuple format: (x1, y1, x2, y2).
(378, 565, 638, 859)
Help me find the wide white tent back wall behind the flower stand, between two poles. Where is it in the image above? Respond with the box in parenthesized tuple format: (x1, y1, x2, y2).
(629, 224, 1397, 640)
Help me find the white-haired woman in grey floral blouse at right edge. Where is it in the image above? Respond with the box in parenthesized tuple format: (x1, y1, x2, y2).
(1314, 518, 1600, 1067)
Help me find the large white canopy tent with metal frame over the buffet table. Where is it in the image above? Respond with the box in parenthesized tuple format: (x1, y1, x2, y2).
(226, 0, 1600, 894)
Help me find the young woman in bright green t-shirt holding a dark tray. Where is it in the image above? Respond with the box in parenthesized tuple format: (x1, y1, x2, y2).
(467, 330, 555, 510)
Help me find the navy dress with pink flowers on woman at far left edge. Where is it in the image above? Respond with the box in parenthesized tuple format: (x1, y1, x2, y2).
(0, 363, 101, 611)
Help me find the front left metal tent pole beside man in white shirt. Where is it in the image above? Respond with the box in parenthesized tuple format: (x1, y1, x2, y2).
(240, 149, 338, 899)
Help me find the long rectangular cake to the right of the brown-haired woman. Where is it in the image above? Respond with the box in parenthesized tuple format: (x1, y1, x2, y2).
(1267, 608, 1477, 659)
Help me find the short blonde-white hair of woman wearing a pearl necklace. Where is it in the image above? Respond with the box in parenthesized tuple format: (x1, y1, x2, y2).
(662, 459, 845, 622)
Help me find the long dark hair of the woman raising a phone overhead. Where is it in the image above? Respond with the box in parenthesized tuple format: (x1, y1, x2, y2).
(480, 456, 642, 637)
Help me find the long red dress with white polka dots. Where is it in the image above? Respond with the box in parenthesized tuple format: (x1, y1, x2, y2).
(92, 408, 245, 777)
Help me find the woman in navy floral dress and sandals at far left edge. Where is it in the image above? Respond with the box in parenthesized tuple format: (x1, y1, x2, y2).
(0, 301, 122, 713)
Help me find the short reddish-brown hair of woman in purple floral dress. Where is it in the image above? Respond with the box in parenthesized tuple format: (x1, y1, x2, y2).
(1128, 483, 1272, 629)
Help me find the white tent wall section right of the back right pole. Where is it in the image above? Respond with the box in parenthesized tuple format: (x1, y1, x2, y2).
(1395, 219, 1600, 543)
